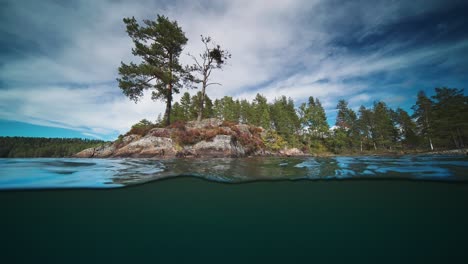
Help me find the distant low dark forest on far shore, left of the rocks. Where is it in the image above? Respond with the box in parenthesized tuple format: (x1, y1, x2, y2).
(0, 137, 104, 158)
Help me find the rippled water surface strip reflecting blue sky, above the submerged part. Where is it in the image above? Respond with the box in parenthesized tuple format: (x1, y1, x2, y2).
(0, 155, 468, 189)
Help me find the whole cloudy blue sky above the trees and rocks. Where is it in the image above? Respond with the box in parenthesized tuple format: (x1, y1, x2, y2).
(0, 0, 468, 140)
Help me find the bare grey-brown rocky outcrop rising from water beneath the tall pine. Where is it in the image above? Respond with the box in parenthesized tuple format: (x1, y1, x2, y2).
(75, 118, 306, 158)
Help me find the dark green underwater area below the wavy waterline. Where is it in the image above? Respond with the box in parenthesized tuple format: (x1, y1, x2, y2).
(0, 177, 468, 263)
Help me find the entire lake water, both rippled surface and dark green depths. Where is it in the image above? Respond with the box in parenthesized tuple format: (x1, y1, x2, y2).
(0, 156, 468, 263)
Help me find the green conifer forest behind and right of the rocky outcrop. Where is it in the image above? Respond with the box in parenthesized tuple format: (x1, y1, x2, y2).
(144, 87, 468, 154)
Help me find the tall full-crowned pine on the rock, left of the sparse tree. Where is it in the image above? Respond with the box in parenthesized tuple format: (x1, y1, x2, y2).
(117, 15, 187, 125)
